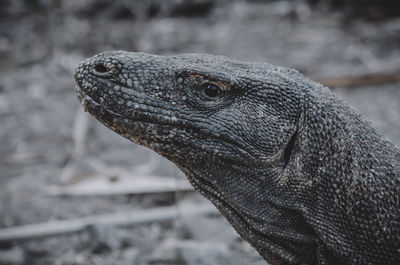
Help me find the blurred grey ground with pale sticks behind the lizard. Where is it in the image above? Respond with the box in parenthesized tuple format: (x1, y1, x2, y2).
(0, 0, 400, 265)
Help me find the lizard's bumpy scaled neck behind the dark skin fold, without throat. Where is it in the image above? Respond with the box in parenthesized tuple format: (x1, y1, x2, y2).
(292, 89, 400, 264)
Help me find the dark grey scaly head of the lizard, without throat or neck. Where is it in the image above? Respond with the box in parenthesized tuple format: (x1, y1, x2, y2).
(75, 51, 301, 165)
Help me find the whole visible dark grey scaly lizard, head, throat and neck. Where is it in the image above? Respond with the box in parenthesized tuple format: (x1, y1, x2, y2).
(75, 51, 400, 264)
